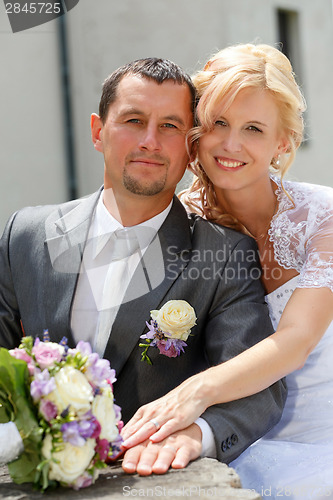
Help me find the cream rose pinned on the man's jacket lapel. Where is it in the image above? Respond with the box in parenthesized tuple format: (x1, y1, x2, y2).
(150, 300, 197, 341)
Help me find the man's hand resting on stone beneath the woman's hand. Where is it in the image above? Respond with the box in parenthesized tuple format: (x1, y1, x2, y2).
(122, 424, 202, 476)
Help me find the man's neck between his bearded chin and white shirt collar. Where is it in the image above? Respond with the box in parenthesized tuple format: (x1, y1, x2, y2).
(103, 189, 173, 227)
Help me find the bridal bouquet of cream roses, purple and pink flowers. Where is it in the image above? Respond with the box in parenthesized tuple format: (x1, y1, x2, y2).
(0, 331, 122, 490)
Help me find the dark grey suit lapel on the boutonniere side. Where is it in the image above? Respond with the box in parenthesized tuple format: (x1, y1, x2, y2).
(105, 197, 192, 374)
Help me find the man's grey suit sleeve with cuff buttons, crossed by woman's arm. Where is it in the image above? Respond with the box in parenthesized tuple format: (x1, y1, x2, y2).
(202, 237, 287, 463)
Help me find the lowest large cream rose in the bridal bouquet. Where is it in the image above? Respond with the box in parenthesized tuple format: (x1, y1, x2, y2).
(42, 434, 96, 485)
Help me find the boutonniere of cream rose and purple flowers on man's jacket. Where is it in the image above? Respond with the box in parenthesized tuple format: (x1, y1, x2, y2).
(139, 300, 197, 365)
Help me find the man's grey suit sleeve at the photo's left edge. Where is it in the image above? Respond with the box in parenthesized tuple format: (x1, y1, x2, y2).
(0, 214, 25, 349)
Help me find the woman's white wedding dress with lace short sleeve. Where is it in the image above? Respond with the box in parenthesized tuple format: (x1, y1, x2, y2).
(230, 178, 333, 500)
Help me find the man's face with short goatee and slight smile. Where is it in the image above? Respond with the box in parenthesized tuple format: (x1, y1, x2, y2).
(92, 75, 193, 196)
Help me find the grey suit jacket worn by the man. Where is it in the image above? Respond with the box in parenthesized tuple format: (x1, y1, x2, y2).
(0, 192, 286, 463)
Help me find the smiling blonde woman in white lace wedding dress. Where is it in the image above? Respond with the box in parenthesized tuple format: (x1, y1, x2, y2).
(124, 44, 333, 499)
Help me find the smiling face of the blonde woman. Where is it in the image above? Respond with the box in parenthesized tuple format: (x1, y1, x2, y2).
(198, 88, 288, 190)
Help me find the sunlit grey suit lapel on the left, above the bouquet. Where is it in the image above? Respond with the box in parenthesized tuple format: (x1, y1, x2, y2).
(44, 191, 100, 345)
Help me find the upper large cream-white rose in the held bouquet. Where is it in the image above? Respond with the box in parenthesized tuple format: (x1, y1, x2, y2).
(47, 366, 94, 413)
